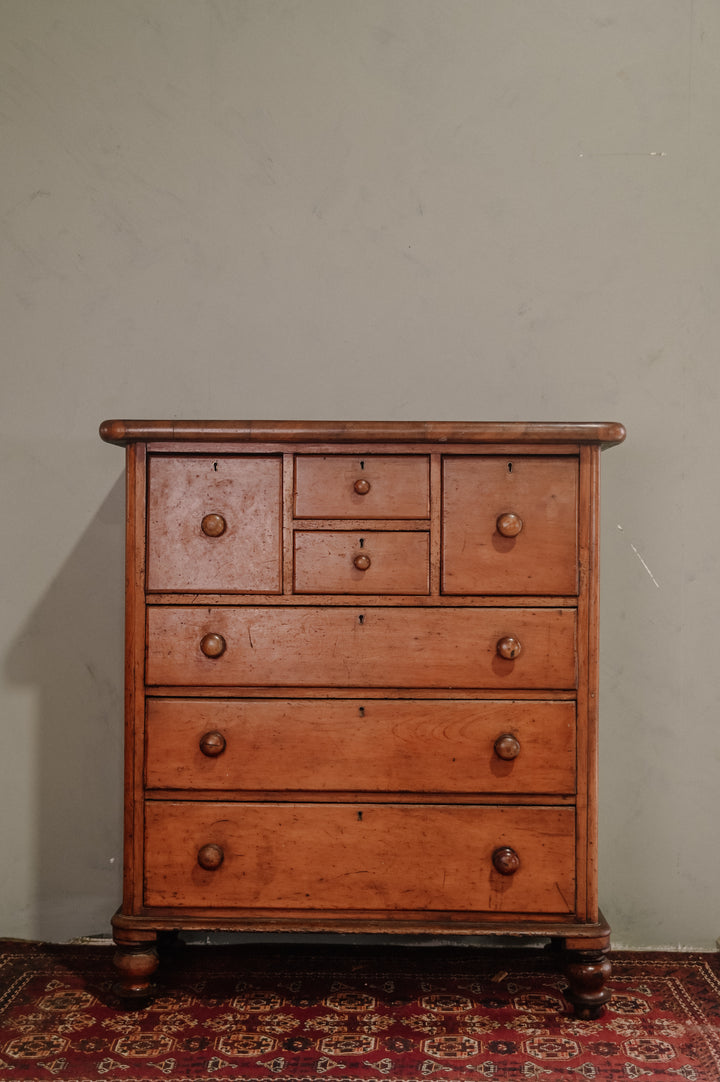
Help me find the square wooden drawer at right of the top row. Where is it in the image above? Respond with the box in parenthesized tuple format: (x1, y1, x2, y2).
(442, 456, 578, 596)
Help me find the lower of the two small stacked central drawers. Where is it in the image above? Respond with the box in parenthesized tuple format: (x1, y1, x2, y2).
(294, 530, 430, 594)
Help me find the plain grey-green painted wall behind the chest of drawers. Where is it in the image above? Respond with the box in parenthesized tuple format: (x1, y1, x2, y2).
(0, 0, 720, 948)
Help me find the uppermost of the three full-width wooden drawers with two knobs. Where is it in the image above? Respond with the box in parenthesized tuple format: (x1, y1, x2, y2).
(146, 606, 576, 688)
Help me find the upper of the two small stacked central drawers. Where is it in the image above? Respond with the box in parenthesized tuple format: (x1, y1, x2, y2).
(294, 454, 430, 518)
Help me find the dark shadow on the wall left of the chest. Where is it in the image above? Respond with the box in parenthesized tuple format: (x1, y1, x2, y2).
(6, 477, 125, 941)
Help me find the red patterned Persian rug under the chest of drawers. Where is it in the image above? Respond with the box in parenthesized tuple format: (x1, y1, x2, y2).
(0, 940, 720, 1082)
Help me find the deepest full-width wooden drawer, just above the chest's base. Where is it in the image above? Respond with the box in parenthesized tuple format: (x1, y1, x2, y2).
(145, 801, 575, 914)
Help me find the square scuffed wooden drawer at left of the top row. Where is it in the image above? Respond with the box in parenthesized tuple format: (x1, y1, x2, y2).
(147, 454, 282, 593)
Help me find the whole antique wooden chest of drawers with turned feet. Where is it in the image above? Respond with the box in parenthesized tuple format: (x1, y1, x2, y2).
(101, 421, 625, 1017)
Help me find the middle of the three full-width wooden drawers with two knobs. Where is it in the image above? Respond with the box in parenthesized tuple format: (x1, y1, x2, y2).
(145, 699, 575, 794)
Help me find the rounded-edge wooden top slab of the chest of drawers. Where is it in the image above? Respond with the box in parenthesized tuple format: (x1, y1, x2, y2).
(100, 420, 625, 447)
